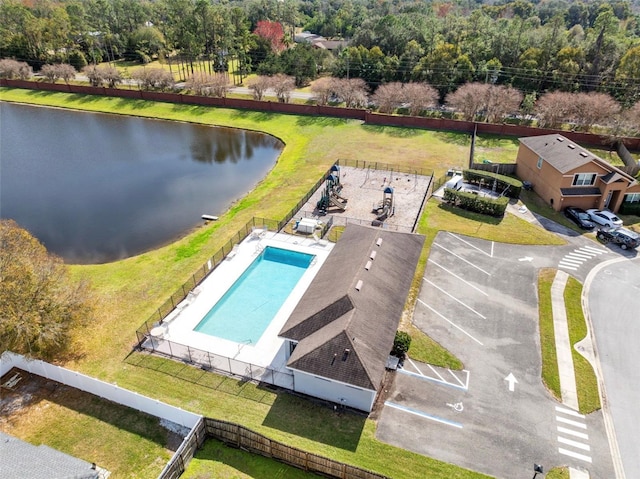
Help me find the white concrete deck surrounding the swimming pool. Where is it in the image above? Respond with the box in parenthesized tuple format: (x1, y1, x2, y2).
(151, 232, 334, 371)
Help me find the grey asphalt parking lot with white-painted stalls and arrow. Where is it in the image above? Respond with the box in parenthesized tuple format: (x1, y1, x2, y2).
(377, 232, 613, 478)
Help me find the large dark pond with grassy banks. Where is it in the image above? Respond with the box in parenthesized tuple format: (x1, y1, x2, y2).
(0, 102, 283, 264)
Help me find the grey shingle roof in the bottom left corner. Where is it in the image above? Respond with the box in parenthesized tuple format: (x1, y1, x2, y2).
(0, 432, 99, 479)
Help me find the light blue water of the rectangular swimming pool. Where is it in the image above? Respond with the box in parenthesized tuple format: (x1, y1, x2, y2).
(194, 246, 314, 344)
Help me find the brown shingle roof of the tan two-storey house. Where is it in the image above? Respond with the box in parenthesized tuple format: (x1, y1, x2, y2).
(519, 135, 635, 184)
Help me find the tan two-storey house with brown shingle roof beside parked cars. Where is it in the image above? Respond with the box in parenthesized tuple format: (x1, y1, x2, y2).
(516, 134, 640, 212)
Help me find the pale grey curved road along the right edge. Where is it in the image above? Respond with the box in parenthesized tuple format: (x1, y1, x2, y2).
(587, 252, 640, 479)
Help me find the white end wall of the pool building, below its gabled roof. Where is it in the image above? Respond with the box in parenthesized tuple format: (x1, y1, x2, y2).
(292, 369, 376, 412)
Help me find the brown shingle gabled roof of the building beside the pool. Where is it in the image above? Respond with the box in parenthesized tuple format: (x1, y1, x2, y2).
(279, 224, 424, 390)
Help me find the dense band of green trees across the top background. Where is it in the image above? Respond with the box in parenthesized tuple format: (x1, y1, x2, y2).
(0, 0, 640, 106)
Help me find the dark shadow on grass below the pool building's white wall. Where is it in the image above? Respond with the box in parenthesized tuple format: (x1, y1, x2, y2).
(262, 393, 366, 451)
